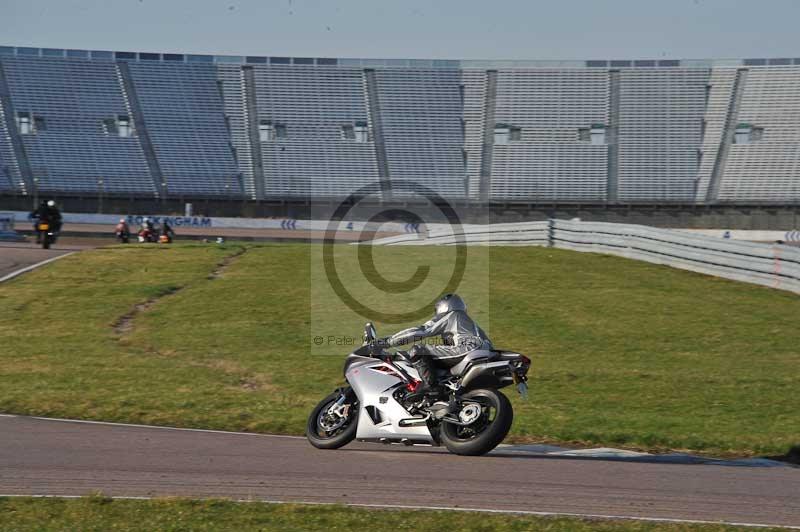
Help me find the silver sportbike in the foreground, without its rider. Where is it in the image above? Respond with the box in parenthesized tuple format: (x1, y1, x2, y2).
(306, 323, 531, 455)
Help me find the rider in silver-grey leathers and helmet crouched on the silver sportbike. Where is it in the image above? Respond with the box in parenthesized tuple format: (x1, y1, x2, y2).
(386, 294, 492, 394)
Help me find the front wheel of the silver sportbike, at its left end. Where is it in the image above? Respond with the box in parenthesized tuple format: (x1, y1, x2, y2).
(306, 388, 358, 449)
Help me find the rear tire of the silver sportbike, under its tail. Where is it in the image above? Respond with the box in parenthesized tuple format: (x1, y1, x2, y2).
(441, 389, 514, 456)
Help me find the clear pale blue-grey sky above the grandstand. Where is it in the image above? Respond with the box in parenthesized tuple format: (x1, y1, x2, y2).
(0, 0, 800, 60)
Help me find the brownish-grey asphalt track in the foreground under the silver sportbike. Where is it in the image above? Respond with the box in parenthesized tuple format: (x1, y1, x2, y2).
(0, 416, 800, 526)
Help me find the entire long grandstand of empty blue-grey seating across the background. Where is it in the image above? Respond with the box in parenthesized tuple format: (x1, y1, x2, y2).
(0, 46, 800, 204)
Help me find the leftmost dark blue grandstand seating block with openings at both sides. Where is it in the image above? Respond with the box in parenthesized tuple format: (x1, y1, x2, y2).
(3, 57, 154, 195)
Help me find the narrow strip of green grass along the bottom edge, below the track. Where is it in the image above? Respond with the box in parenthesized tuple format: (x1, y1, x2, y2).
(0, 496, 768, 532)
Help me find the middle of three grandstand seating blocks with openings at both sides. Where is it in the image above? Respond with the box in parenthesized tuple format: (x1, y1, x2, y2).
(247, 65, 378, 197)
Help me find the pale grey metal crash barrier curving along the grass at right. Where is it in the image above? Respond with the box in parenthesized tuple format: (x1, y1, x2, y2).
(372, 220, 800, 293)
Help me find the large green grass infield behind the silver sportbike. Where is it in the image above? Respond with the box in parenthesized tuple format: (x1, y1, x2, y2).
(0, 244, 800, 455)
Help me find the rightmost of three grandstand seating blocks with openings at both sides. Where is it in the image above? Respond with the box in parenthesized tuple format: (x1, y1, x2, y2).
(491, 69, 609, 202)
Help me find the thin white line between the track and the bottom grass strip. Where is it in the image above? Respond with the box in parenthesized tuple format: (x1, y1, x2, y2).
(0, 493, 800, 530)
